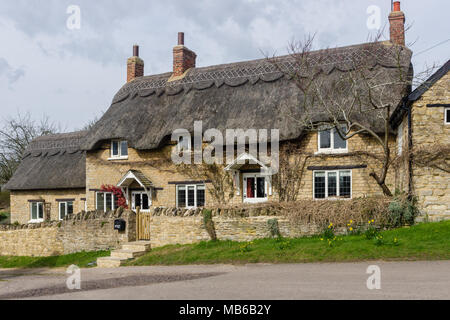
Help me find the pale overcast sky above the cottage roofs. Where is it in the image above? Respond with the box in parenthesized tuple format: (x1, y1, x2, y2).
(0, 0, 450, 130)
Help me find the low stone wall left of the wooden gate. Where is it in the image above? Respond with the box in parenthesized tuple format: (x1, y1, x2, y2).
(0, 210, 136, 256)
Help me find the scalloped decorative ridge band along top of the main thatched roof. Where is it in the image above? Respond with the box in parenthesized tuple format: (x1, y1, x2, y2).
(112, 42, 408, 104)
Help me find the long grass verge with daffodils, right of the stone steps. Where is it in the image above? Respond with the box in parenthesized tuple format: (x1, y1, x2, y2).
(127, 221, 450, 266)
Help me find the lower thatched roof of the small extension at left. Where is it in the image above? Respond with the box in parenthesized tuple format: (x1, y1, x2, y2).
(4, 131, 86, 190)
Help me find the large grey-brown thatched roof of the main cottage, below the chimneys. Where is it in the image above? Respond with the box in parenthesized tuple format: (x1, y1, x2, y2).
(83, 43, 411, 150)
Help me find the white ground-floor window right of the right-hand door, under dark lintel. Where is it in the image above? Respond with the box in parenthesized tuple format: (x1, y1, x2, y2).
(313, 170, 352, 199)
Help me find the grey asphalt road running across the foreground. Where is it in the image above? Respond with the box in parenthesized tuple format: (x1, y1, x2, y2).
(0, 261, 450, 300)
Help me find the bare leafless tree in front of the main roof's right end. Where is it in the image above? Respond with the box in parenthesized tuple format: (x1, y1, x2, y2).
(268, 34, 433, 196)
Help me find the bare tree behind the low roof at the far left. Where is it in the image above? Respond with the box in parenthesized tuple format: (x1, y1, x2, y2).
(0, 113, 61, 184)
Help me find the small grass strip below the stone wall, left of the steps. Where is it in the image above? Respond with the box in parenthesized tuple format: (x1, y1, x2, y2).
(0, 251, 110, 268)
